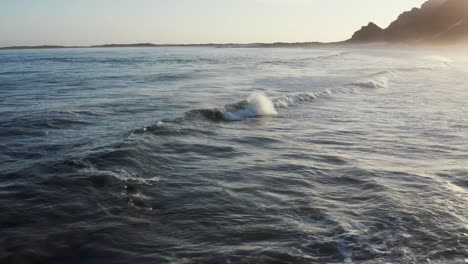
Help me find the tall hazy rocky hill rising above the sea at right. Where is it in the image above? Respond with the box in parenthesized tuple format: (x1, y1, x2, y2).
(348, 0, 468, 43)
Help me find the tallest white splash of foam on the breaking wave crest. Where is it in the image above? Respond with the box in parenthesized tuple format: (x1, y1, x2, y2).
(223, 93, 278, 120)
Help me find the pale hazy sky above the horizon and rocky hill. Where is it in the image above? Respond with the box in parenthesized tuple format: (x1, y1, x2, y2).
(0, 0, 424, 46)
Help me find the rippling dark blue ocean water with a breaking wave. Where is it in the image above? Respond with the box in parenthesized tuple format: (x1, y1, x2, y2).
(0, 45, 468, 264)
